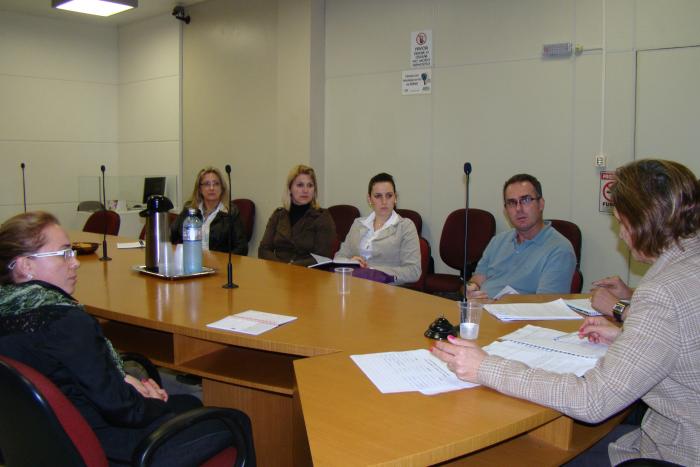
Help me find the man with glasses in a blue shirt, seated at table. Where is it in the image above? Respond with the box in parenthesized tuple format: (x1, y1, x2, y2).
(467, 174, 576, 298)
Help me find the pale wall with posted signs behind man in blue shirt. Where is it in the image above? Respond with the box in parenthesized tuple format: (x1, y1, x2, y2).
(324, 0, 700, 288)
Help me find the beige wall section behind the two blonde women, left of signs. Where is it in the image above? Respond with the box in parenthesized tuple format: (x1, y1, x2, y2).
(183, 0, 323, 255)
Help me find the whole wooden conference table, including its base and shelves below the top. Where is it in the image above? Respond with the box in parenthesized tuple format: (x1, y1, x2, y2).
(71, 232, 620, 466)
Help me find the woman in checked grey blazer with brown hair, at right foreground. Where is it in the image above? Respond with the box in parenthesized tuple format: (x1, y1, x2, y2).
(433, 159, 700, 466)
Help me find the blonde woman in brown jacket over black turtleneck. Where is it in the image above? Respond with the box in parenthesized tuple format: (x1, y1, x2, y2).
(258, 165, 336, 266)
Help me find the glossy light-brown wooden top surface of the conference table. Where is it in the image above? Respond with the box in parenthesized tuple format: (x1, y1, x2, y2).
(70, 232, 592, 466)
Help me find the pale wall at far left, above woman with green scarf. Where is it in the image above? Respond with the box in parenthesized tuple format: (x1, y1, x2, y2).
(0, 11, 118, 228)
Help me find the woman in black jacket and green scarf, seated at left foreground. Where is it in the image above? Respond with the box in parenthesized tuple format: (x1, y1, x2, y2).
(0, 212, 255, 466)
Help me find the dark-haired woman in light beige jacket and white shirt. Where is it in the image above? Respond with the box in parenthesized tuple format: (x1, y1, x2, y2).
(335, 172, 421, 285)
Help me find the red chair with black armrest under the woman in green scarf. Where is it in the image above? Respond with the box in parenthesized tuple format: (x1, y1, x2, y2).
(0, 356, 252, 467)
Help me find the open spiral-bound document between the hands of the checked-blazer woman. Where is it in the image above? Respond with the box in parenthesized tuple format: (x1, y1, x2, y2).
(484, 325, 608, 376)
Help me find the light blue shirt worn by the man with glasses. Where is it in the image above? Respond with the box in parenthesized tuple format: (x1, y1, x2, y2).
(474, 222, 576, 297)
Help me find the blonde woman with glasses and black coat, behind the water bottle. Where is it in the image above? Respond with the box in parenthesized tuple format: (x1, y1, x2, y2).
(170, 167, 248, 256)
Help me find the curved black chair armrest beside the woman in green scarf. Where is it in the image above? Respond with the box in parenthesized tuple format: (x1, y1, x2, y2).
(132, 407, 248, 467)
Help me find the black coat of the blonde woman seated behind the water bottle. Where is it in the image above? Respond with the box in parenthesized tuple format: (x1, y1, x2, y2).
(170, 204, 248, 256)
